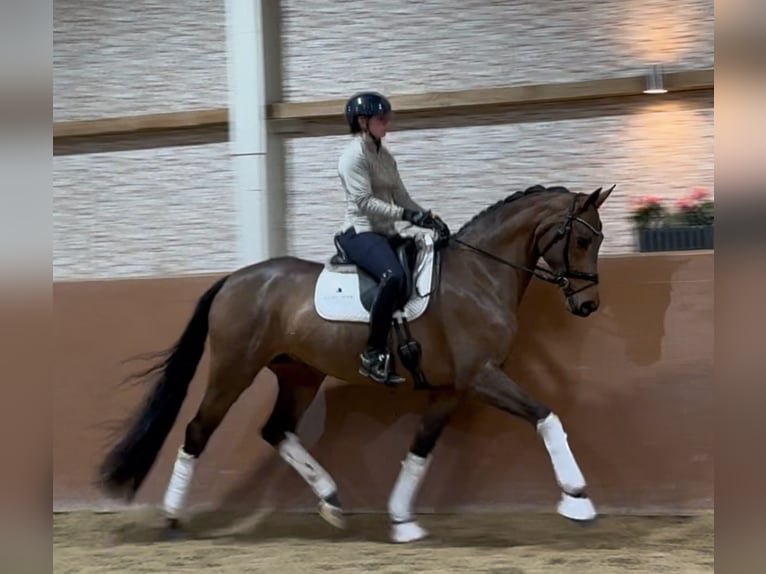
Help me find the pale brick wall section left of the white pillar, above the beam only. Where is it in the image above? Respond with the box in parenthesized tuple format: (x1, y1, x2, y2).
(53, 0, 227, 121)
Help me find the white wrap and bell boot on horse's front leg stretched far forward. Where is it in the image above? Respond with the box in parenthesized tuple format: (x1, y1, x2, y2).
(537, 413, 596, 520)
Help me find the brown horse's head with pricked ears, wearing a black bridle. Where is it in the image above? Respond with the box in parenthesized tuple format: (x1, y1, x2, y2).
(535, 186, 614, 317)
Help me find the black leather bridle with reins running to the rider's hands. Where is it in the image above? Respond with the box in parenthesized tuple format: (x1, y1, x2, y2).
(444, 196, 603, 297)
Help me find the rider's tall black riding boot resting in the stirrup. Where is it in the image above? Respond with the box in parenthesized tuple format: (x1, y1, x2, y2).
(359, 275, 405, 385)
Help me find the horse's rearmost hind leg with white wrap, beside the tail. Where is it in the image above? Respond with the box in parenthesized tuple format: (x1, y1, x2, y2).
(163, 354, 261, 529)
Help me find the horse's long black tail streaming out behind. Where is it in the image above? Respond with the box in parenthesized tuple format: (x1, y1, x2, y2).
(100, 276, 228, 500)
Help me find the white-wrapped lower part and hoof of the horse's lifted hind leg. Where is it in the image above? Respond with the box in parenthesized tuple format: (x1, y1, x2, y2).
(277, 432, 346, 528)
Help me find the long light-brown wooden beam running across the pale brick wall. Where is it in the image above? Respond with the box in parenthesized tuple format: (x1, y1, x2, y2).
(53, 68, 714, 141)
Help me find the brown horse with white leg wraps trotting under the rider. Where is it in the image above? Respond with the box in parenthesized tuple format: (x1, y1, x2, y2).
(98, 185, 615, 543)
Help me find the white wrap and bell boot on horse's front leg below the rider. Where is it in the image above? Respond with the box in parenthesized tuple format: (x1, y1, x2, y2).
(388, 452, 430, 542)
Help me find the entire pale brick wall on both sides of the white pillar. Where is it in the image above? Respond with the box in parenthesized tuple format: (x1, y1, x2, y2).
(53, 0, 714, 279)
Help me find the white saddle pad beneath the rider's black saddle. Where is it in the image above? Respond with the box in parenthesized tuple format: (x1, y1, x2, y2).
(314, 232, 434, 323)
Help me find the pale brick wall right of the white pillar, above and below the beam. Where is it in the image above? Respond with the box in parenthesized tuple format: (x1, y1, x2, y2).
(283, 0, 714, 257)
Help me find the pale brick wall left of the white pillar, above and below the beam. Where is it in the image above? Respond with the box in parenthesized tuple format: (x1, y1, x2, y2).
(53, 0, 237, 280)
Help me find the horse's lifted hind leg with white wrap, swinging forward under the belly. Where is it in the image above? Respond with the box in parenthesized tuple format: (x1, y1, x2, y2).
(261, 356, 345, 528)
